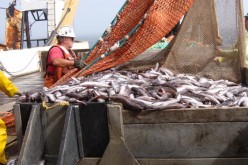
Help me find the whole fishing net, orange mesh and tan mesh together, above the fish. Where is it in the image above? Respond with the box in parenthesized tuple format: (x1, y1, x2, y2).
(52, 0, 247, 85)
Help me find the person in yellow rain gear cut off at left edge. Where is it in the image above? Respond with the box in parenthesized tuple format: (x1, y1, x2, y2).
(0, 70, 23, 164)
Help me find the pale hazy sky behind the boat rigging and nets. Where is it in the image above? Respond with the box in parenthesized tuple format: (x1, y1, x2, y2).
(0, 0, 248, 44)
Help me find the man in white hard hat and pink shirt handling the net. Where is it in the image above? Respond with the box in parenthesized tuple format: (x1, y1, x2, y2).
(44, 25, 85, 88)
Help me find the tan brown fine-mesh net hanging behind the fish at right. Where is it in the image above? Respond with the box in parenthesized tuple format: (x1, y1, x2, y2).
(120, 0, 246, 82)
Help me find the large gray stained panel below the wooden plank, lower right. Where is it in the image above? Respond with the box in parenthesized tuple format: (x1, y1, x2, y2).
(124, 122, 248, 158)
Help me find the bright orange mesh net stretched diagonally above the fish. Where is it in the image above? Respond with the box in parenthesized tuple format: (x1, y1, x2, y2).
(54, 0, 194, 86)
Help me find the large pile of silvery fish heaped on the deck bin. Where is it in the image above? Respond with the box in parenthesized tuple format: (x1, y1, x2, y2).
(18, 64, 248, 110)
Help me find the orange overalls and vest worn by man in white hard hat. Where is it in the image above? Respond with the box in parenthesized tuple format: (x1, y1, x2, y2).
(44, 45, 78, 88)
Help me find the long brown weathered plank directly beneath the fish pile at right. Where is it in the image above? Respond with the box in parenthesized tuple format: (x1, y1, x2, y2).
(122, 107, 248, 124)
